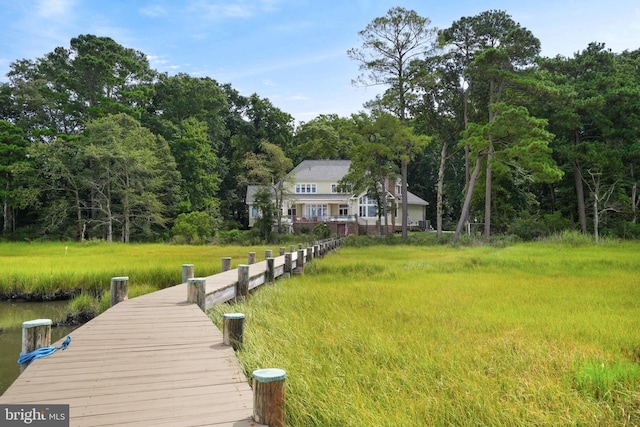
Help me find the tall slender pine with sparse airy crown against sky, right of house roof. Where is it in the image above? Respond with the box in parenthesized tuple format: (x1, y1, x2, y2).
(347, 7, 436, 241)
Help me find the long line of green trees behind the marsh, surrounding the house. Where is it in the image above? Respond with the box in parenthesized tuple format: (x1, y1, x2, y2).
(0, 7, 640, 242)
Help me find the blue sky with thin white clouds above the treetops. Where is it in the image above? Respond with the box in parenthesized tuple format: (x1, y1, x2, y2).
(0, 0, 640, 121)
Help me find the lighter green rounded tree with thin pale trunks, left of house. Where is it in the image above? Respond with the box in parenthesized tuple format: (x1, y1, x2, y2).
(83, 114, 177, 242)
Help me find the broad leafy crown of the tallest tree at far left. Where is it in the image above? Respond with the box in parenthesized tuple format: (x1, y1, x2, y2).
(7, 34, 156, 139)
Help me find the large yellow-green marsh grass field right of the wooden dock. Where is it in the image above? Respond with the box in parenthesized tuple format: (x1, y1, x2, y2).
(209, 243, 640, 426)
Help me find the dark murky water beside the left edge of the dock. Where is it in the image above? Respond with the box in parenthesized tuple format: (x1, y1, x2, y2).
(0, 301, 75, 395)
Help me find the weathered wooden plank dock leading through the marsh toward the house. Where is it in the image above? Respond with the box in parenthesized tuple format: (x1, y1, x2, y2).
(0, 242, 340, 427)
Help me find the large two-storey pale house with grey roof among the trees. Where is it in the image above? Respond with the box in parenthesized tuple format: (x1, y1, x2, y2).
(246, 160, 429, 235)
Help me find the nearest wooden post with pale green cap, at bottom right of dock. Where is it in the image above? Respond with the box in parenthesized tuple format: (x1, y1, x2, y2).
(253, 368, 287, 427)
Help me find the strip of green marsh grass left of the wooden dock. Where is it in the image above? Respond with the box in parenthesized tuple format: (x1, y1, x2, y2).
(0, 243, 278, 297)
